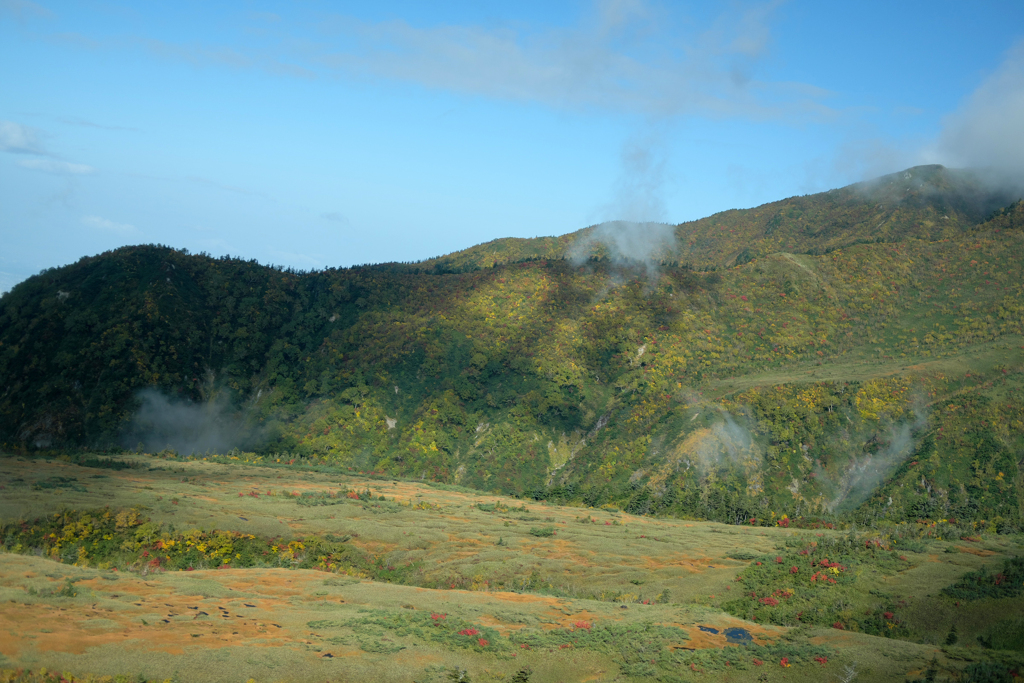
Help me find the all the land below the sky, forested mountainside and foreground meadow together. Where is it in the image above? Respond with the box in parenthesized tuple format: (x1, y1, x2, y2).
(0, 165, 1024, 683)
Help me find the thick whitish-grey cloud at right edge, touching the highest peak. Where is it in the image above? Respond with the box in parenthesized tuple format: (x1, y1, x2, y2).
(925, 40, 1024, 173)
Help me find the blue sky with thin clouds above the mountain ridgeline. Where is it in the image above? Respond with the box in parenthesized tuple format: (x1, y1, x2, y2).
(0, 0, 1024, 291)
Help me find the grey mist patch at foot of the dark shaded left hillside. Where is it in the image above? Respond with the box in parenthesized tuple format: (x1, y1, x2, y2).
(122, 389, 259, 455)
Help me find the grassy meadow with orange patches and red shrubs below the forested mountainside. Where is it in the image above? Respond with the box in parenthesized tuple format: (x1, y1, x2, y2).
(0, 455, 1024, 683)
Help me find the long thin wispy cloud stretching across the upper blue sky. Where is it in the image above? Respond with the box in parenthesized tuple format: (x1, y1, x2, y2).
(29, 0, 823, 122)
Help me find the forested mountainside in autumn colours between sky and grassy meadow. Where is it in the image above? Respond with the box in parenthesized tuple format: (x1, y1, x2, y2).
(0, 167, 1024, 529)
